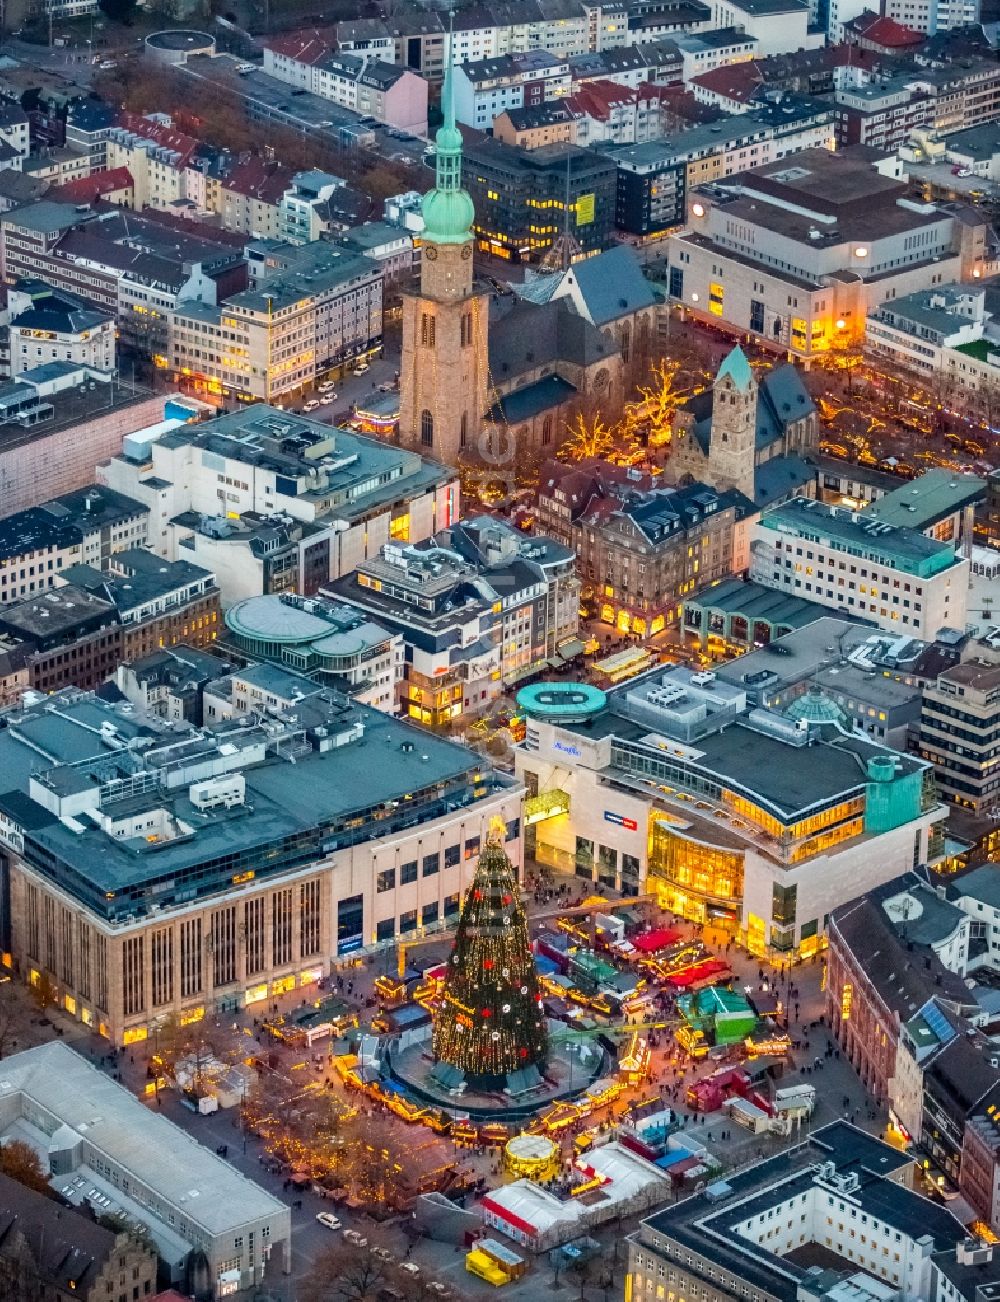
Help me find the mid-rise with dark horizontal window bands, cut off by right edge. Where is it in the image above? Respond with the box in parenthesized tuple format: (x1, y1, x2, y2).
(919, 656, 1000, 815)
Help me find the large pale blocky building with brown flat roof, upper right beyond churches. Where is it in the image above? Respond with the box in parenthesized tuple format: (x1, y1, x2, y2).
(668, 146, 986, 358)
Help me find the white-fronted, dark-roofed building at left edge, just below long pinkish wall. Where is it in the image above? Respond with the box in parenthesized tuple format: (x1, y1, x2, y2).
(0, 484, 148, 605)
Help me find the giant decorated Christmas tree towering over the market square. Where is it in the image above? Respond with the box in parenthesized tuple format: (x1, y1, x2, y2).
(434, 832, 546, 1086)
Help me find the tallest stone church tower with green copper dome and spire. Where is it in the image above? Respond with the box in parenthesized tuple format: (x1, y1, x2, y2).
(400, 38, 490, 465)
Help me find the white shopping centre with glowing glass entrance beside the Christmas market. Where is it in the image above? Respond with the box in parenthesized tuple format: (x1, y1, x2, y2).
(516, 665, 945, 956)
